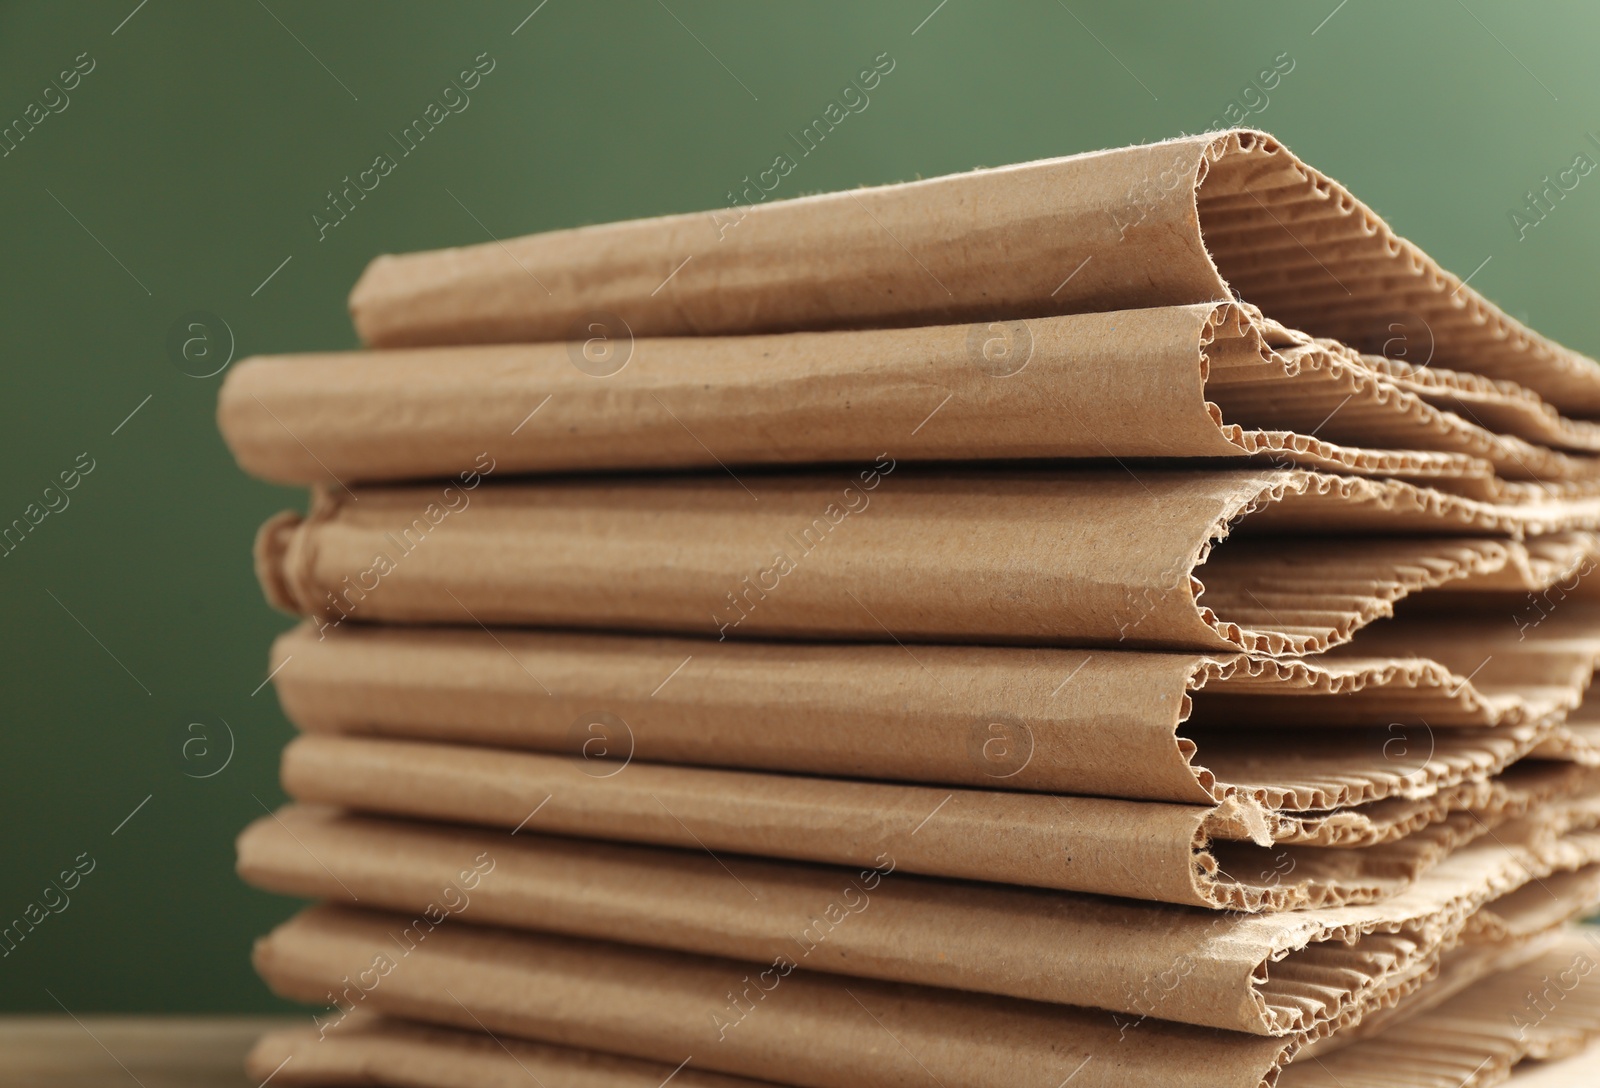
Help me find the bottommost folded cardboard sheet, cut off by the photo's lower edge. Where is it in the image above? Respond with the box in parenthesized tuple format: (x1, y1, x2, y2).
(248, 934, 1600, 1088)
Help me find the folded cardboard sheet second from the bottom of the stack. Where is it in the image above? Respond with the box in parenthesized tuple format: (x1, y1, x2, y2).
(254, 907, 1600, 1088)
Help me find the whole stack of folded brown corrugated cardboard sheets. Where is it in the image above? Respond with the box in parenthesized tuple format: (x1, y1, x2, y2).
(219, 131, 1600, 1088)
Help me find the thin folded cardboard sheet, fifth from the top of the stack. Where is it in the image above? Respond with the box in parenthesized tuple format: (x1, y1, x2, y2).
(283, 736, 1587, 910)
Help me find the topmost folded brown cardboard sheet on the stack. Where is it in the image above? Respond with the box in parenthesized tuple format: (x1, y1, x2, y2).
(350, 131, 1600, 416)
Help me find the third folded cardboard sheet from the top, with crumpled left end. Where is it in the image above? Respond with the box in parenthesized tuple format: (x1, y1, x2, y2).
(256, 459, 1600, 654)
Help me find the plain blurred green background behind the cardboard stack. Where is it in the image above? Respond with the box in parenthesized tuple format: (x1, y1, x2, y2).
(0, 0, 1600, 1013)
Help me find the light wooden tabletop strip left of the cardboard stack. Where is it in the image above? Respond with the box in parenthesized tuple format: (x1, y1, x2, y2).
(0, 1016, 306, 1088)
